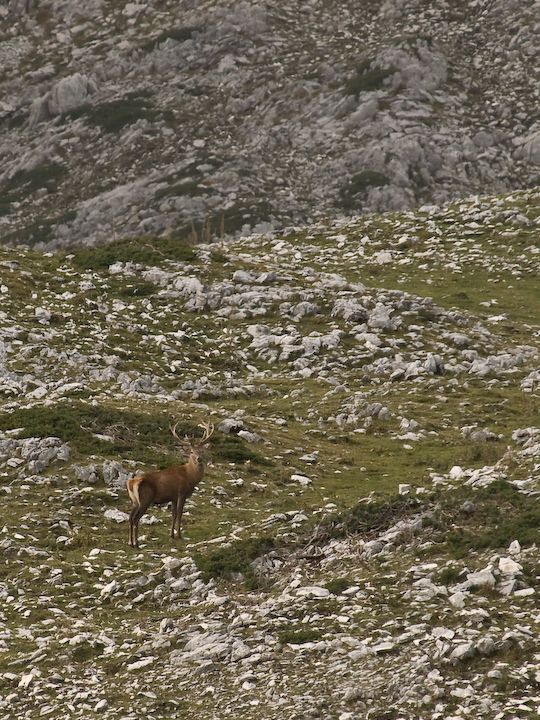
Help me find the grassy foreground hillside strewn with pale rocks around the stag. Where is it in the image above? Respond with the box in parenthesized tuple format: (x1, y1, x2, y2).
(0, 191, 540, 720)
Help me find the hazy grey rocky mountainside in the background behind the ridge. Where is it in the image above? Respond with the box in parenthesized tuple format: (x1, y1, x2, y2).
(0, 0, 540, 248)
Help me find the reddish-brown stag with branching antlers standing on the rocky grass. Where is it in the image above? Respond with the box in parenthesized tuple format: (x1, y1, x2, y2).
(127, 423, 214, 547)
